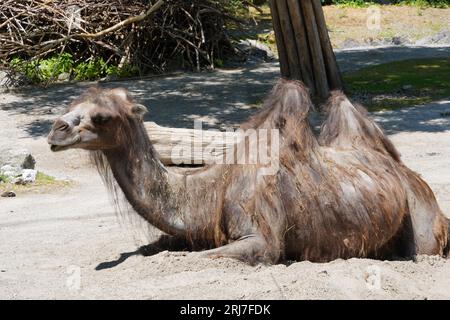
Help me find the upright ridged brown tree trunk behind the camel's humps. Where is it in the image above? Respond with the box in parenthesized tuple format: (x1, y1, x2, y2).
(270, 0, 342, 99)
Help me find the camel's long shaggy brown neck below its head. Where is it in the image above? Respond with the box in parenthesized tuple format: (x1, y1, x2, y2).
(104, 121, 186, 236)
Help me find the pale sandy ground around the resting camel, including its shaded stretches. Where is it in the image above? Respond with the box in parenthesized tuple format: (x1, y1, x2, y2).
(0, 48, 450, 299)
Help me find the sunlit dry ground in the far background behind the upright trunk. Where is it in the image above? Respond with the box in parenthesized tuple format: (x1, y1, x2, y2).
(246, 5, 450, 51)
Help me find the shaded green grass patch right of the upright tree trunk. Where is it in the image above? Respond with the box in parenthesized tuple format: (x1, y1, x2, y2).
(344, 58, 450, 111)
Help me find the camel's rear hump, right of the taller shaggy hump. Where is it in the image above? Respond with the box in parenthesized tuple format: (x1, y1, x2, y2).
(319, 91, 401, 162)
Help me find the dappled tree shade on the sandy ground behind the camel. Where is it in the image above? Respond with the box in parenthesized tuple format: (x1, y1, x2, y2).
(0, 47, 450, 137)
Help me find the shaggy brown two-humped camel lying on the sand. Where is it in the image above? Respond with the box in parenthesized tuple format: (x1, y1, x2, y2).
(48, 79, 450, 264)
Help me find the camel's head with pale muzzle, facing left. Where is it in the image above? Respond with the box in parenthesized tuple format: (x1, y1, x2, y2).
(48, 88, 147, 151)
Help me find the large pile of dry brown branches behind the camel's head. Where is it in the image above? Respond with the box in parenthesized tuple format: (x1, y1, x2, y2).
(0, 0, 242, 72)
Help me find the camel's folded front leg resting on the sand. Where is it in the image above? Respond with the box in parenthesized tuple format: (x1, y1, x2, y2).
(194, 234, 280, 265)
